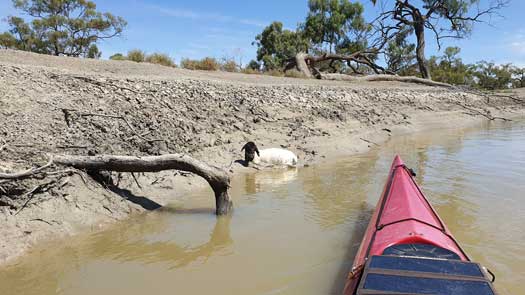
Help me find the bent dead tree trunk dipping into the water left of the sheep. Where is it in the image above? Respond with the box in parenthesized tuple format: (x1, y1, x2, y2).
(53, 154, 232, 215)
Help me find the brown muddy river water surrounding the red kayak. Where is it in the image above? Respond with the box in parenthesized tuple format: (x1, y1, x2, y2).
(0, 122, 525, 295)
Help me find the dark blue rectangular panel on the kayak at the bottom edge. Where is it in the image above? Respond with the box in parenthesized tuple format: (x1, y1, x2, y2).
(356, 255, 495, 295)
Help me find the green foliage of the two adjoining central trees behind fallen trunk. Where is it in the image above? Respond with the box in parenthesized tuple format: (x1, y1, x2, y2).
(252, 0, 368, 71)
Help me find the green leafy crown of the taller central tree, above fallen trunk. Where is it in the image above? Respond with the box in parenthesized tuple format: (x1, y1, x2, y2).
(303, 0, 370, 53)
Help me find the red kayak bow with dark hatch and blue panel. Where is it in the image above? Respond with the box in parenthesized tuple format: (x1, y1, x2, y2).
(344, 156, 497, 295)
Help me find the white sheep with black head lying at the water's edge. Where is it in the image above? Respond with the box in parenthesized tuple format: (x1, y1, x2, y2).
(242, 141, 298, 166)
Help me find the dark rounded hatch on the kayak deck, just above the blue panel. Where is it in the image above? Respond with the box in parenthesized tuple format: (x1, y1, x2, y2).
(383, 244, 461, 260)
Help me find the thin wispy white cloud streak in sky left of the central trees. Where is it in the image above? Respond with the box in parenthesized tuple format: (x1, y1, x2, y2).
(151, 6, 266, 27)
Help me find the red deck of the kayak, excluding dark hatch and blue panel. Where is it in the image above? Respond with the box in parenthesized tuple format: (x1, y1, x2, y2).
(344, 156, 469, 295)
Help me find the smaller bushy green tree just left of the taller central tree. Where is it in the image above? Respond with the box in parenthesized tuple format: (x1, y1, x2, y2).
(253, 22, 308, 71)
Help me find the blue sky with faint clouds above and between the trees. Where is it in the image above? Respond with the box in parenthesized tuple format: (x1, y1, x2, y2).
(0, 0, 525, 66)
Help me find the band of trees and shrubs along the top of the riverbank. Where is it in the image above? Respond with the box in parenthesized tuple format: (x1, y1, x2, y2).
(0, 0, 525, 90)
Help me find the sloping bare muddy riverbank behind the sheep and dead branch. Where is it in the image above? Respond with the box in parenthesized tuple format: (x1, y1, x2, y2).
(0, 50, 523, 262)
